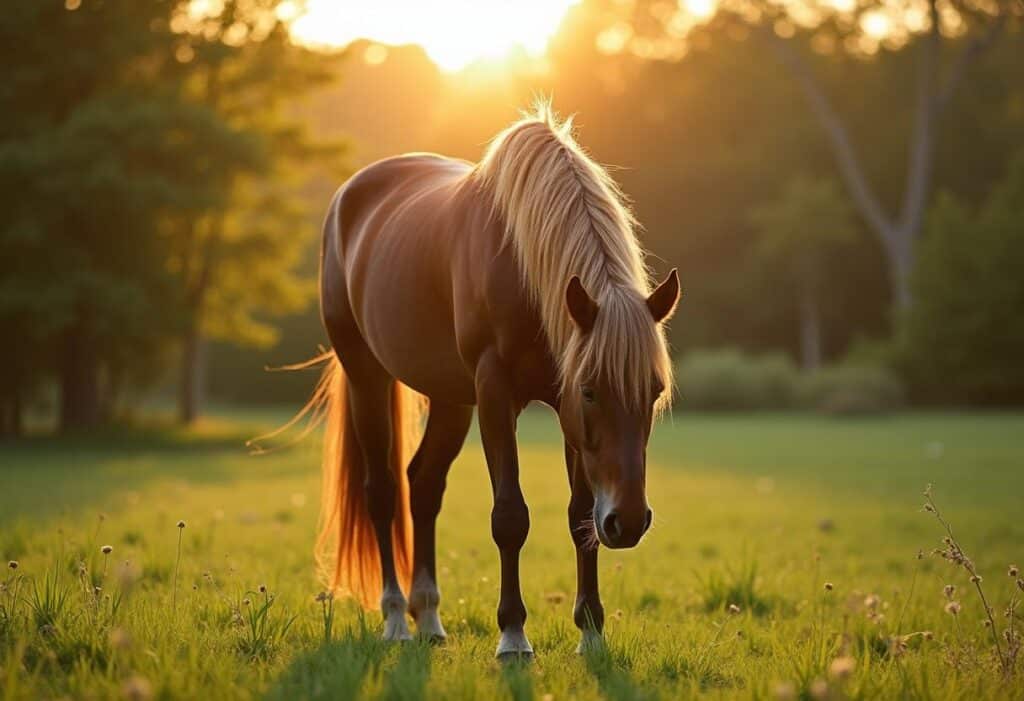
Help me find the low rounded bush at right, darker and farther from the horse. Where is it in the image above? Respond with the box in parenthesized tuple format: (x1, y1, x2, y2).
(798, 364, 903, 414)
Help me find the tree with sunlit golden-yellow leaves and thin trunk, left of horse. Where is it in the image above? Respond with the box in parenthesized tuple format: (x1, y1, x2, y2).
(165, 0, 344, 423)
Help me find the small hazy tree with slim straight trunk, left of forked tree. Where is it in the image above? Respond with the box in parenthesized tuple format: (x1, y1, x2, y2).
(751, 177, 857, 370)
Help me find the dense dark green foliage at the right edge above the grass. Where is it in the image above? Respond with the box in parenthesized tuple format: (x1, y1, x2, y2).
(903, 151, 1024, 404)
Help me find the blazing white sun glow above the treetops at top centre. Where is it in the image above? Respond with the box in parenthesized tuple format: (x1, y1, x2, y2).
(279, 0, 580, 72)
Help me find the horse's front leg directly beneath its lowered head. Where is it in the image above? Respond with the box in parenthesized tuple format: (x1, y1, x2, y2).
(565, 443, 604, 653)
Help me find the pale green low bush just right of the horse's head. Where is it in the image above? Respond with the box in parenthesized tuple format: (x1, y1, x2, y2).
(676, 349, 798, 410)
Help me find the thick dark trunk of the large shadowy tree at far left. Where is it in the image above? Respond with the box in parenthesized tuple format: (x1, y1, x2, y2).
(60, 323, 100, 432)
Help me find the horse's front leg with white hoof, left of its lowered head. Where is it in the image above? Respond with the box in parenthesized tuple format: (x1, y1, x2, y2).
(476, 353, 534, 659)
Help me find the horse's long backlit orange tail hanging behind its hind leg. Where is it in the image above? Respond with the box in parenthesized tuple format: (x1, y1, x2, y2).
(307, 351, 423, 608)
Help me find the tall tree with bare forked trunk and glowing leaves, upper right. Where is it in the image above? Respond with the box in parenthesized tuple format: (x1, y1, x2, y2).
(609, 0, 1024, 309)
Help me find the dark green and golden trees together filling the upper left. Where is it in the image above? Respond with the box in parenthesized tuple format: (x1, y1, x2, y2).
(0, 0, 344, 433)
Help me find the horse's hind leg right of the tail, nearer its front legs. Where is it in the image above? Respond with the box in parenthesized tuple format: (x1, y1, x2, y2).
(409, 400, 473, 642)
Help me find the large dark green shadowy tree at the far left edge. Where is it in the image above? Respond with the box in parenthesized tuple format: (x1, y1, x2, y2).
(0, 0, 217, 429)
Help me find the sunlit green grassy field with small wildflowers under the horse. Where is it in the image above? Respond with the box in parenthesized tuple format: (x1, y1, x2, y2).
(0, 410, 1024, 701)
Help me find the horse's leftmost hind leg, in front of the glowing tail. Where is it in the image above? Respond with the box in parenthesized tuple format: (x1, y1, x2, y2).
(348, 370, 412, 641)
